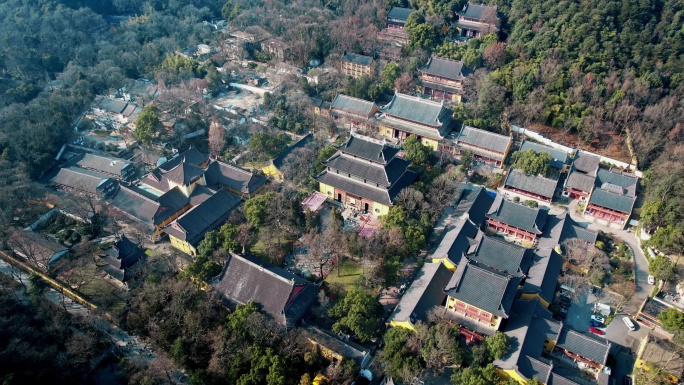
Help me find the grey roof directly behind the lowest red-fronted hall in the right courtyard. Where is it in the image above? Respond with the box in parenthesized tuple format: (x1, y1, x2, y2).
(468, 236, 532, 277)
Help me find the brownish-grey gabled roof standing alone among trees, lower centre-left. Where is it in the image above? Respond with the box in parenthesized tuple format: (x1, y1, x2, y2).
(214, 254, 317, 326)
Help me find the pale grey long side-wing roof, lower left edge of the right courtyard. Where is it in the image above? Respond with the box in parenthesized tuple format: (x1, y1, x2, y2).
(388, 262, 453, 324)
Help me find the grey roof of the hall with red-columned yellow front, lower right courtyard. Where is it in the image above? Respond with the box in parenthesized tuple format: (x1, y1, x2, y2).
(445, 261, 520, 318)
